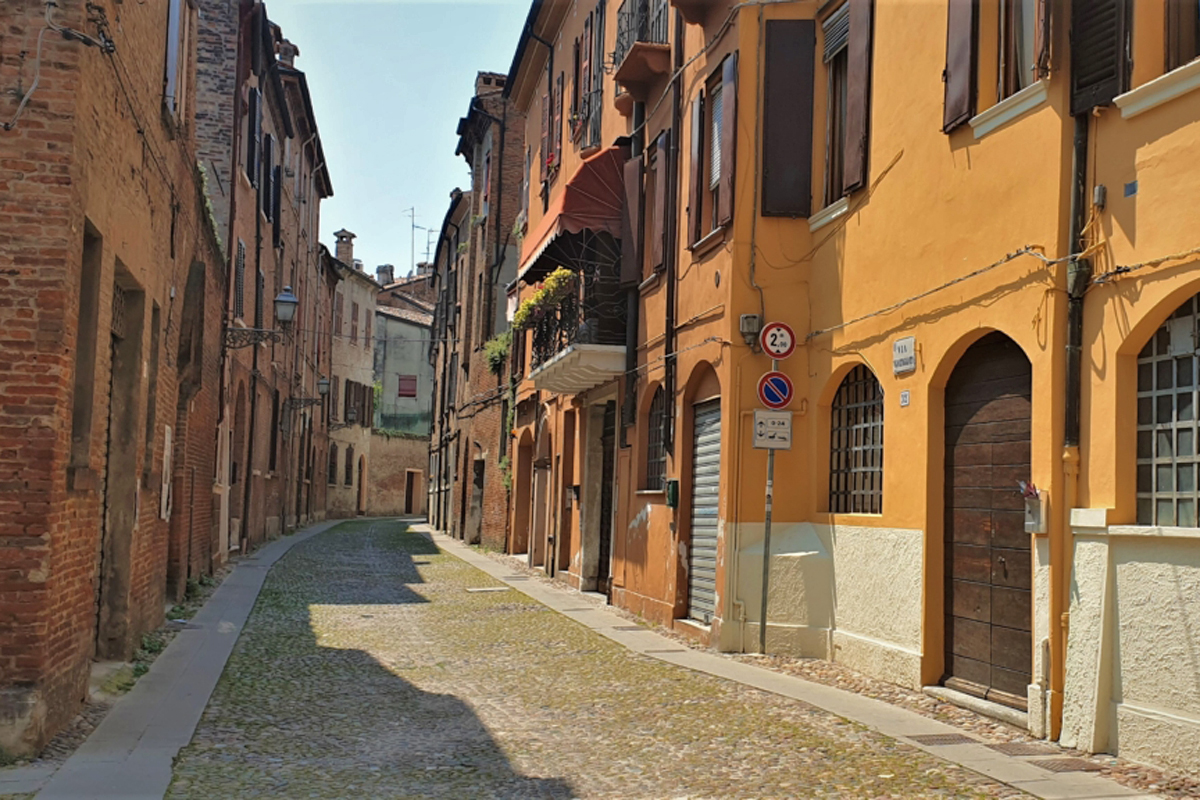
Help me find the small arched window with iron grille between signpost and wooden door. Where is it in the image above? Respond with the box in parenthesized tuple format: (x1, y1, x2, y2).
(829, 365, 883, 513)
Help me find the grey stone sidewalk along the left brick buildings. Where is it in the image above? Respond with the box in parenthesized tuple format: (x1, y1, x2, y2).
(0, 519, 343, 800)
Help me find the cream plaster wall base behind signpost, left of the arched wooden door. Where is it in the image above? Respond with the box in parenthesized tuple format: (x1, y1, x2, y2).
(736, 523, 924, 686)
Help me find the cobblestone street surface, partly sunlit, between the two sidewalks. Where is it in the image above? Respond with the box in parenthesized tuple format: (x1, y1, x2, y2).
(167, 521, 1025, 800)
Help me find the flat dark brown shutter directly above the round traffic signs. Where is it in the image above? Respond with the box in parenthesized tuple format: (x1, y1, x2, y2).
(762, 19, 817, 217)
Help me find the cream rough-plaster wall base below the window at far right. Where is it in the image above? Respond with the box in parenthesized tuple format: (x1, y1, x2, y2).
(1061, 527, 1200, 769)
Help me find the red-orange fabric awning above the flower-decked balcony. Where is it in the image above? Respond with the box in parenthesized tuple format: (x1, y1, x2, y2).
(517, 146, 629, 283)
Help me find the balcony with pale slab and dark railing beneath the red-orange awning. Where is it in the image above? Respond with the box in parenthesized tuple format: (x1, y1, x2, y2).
(529, 269, 625, 395)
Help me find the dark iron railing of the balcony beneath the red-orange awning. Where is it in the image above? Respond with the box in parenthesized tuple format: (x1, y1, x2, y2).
(529, 271, 625, 369)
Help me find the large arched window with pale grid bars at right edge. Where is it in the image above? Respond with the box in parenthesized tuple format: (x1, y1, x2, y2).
(1138, 295, 1200, 528)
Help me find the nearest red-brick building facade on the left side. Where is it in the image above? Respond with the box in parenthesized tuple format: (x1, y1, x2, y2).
(0, 0, 224, 754)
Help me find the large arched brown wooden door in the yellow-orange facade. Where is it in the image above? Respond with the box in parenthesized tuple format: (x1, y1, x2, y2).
(943, 333, 1033, 709)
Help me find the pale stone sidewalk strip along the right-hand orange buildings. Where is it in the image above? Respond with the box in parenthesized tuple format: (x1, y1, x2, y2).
(424, 525, 1157, 800)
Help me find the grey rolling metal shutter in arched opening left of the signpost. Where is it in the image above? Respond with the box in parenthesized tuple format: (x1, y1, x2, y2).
(688, 399, 721, 625)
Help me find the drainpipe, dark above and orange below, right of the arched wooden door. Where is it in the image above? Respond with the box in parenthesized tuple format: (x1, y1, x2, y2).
(1050, 113, 1092, 739)
